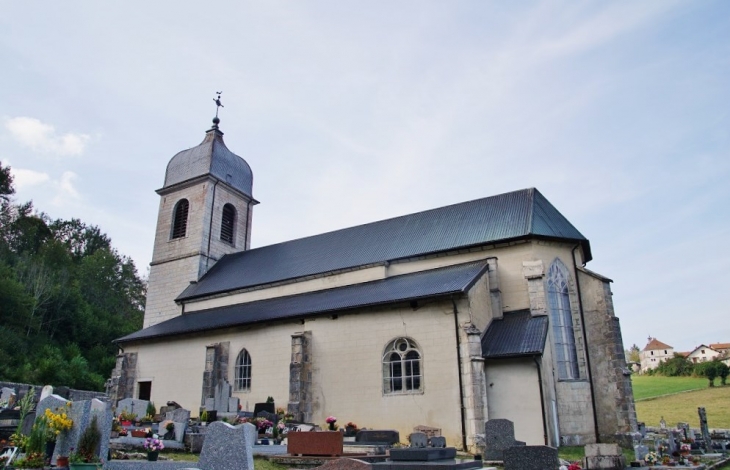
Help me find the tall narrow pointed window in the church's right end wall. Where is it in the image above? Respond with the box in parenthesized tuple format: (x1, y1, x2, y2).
(547, 259, 580, 380)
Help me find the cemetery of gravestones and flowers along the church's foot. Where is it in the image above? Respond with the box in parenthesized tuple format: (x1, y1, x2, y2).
(0, 386, 730, 470)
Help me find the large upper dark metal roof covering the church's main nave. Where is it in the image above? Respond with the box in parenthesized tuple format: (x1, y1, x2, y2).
(178, 188, 591, 300)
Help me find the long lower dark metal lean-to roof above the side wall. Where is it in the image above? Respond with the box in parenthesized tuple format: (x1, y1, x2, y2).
(115, 261, 487, 343)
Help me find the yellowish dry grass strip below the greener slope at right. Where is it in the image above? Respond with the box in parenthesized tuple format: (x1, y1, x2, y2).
(636, 380, 730, 429)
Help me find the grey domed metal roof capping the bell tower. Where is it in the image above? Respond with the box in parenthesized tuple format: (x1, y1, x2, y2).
(163, 124, 253, 199)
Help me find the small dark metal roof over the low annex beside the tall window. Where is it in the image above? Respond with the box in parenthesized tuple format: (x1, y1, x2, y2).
(482, 310, 548, 359)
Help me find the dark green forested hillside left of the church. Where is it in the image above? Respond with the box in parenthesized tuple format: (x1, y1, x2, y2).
(0, 164, 146, 390)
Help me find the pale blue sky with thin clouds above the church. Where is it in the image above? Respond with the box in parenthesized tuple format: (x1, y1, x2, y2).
(0, 0, 730, 351)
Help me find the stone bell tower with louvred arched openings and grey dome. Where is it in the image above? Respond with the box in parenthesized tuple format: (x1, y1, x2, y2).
(144, 113, 258, 328)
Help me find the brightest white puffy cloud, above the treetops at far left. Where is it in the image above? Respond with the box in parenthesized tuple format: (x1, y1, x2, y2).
(5, 116, 91, 156)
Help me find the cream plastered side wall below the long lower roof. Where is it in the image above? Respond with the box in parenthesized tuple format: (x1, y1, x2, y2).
(125, 302, 461, 447)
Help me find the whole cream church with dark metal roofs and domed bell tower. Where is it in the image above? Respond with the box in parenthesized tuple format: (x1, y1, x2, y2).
(112, 117, 636, 450)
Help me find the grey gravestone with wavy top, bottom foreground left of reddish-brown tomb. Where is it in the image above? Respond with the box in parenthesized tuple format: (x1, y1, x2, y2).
(198, 421, 256, 470)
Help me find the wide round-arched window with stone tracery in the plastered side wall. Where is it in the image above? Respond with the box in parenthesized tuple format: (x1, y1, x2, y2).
(383, 338, 423, 394)
